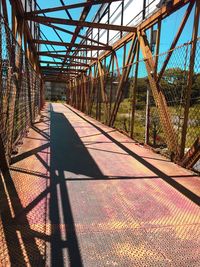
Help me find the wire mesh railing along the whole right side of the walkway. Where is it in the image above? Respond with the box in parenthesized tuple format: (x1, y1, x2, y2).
(71, 39, 200, 174)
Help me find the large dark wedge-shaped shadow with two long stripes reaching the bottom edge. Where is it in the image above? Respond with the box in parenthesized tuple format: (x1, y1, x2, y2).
(50, 108, 103, 267)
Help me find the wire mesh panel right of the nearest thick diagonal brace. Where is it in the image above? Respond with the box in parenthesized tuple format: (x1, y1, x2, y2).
(158, 39, 200, 171)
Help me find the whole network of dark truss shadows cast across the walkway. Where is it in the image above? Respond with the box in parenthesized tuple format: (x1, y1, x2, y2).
(0, 102, 200, 267)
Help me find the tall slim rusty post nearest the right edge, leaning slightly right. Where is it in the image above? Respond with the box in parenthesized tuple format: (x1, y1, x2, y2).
(180, 1, 200, 158)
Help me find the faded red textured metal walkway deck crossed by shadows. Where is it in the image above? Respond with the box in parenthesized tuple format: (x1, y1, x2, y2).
(0, 104, 200, 267)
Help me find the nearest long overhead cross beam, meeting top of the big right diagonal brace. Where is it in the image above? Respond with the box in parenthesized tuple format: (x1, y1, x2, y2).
(24, 15, 136, 32)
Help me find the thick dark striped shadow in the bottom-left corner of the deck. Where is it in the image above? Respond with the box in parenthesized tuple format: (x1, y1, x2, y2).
(0, 172, 45, 266)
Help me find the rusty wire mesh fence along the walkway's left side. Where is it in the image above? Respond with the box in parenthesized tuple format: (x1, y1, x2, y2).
(0, 18, 41, 163)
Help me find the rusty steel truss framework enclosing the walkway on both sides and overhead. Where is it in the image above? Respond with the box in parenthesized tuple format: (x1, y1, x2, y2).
(1, 0, 200, 174)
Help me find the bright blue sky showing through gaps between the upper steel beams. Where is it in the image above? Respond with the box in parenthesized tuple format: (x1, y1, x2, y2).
(3, 0, 200, 72)
